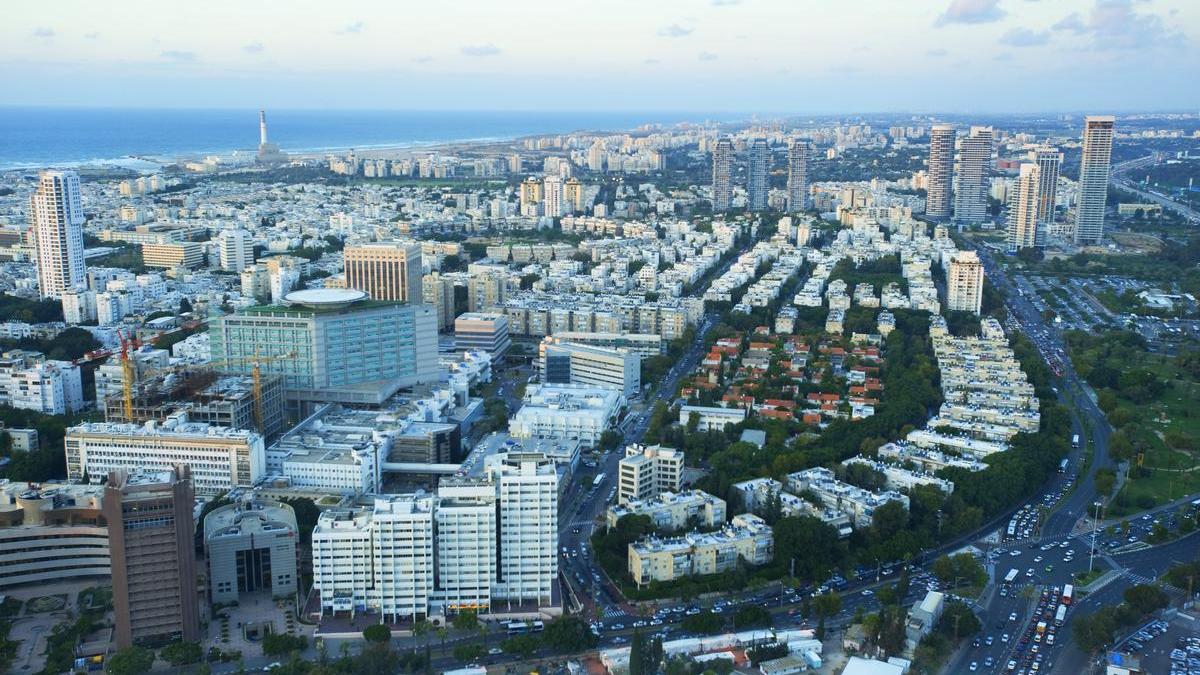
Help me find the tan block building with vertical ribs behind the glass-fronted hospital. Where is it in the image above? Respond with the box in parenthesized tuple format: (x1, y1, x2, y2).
(342, 236, 421, 303)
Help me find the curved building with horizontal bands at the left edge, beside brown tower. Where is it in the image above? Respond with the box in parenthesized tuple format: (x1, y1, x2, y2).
(0, 479, 112, 589)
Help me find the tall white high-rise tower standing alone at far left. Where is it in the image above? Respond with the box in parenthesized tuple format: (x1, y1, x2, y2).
(29, 171, 86, 298)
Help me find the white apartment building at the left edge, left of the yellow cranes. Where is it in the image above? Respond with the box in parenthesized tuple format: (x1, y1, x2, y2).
(0, 350, 84, 414)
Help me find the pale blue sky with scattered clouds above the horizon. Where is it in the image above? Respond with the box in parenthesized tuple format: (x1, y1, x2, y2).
(0, 0, 1200, 114)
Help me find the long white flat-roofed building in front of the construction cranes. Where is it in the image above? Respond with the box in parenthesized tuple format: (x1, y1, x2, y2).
(65, 414, 266, 495)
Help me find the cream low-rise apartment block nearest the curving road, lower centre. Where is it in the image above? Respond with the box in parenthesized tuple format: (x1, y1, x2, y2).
(629, 513, 775, 587)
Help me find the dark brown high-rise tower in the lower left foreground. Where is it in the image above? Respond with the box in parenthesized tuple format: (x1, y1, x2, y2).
(103, 465, 200, 647)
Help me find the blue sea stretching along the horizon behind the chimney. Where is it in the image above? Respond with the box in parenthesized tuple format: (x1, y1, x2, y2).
(0, 107, 736, 169)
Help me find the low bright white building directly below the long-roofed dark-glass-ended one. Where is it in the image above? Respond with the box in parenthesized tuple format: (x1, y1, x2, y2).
(509, 384, 625, 448)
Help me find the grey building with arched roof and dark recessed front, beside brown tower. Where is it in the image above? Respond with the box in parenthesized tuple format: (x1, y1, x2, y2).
(204, 498, 300, 604)
